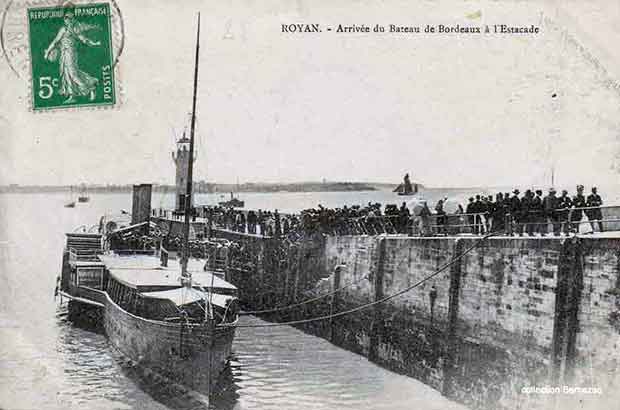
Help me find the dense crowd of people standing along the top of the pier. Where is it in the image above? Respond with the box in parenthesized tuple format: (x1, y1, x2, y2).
(154, 185, 604, 239)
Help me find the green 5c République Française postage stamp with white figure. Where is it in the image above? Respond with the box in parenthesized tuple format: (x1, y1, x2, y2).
(27, 3, 116, 111)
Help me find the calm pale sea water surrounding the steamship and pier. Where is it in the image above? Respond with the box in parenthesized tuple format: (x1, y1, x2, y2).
(0, 192, 524, 410)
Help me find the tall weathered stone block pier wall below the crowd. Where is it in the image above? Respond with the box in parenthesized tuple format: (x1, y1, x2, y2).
(223, 232, 620, 409)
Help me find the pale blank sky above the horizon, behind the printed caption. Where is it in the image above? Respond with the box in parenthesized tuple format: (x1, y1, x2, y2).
(0, 0, 620, 187)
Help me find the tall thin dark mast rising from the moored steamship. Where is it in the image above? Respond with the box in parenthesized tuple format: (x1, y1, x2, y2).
(181, 12, 200, 279)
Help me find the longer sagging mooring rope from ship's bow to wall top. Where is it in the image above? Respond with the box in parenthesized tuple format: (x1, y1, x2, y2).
(218, 231, 499, 328)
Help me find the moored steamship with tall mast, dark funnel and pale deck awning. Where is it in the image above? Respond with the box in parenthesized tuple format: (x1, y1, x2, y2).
(57, 16, 239, 395)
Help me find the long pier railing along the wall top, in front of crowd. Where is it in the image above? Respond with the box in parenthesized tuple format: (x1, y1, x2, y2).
(153, 206, 620, 237)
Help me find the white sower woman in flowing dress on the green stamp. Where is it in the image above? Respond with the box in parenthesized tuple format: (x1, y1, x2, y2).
(44, 12, 101, 104)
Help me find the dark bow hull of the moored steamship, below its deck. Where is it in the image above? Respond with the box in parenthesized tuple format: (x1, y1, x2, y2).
(103, 294, 235, 395)
